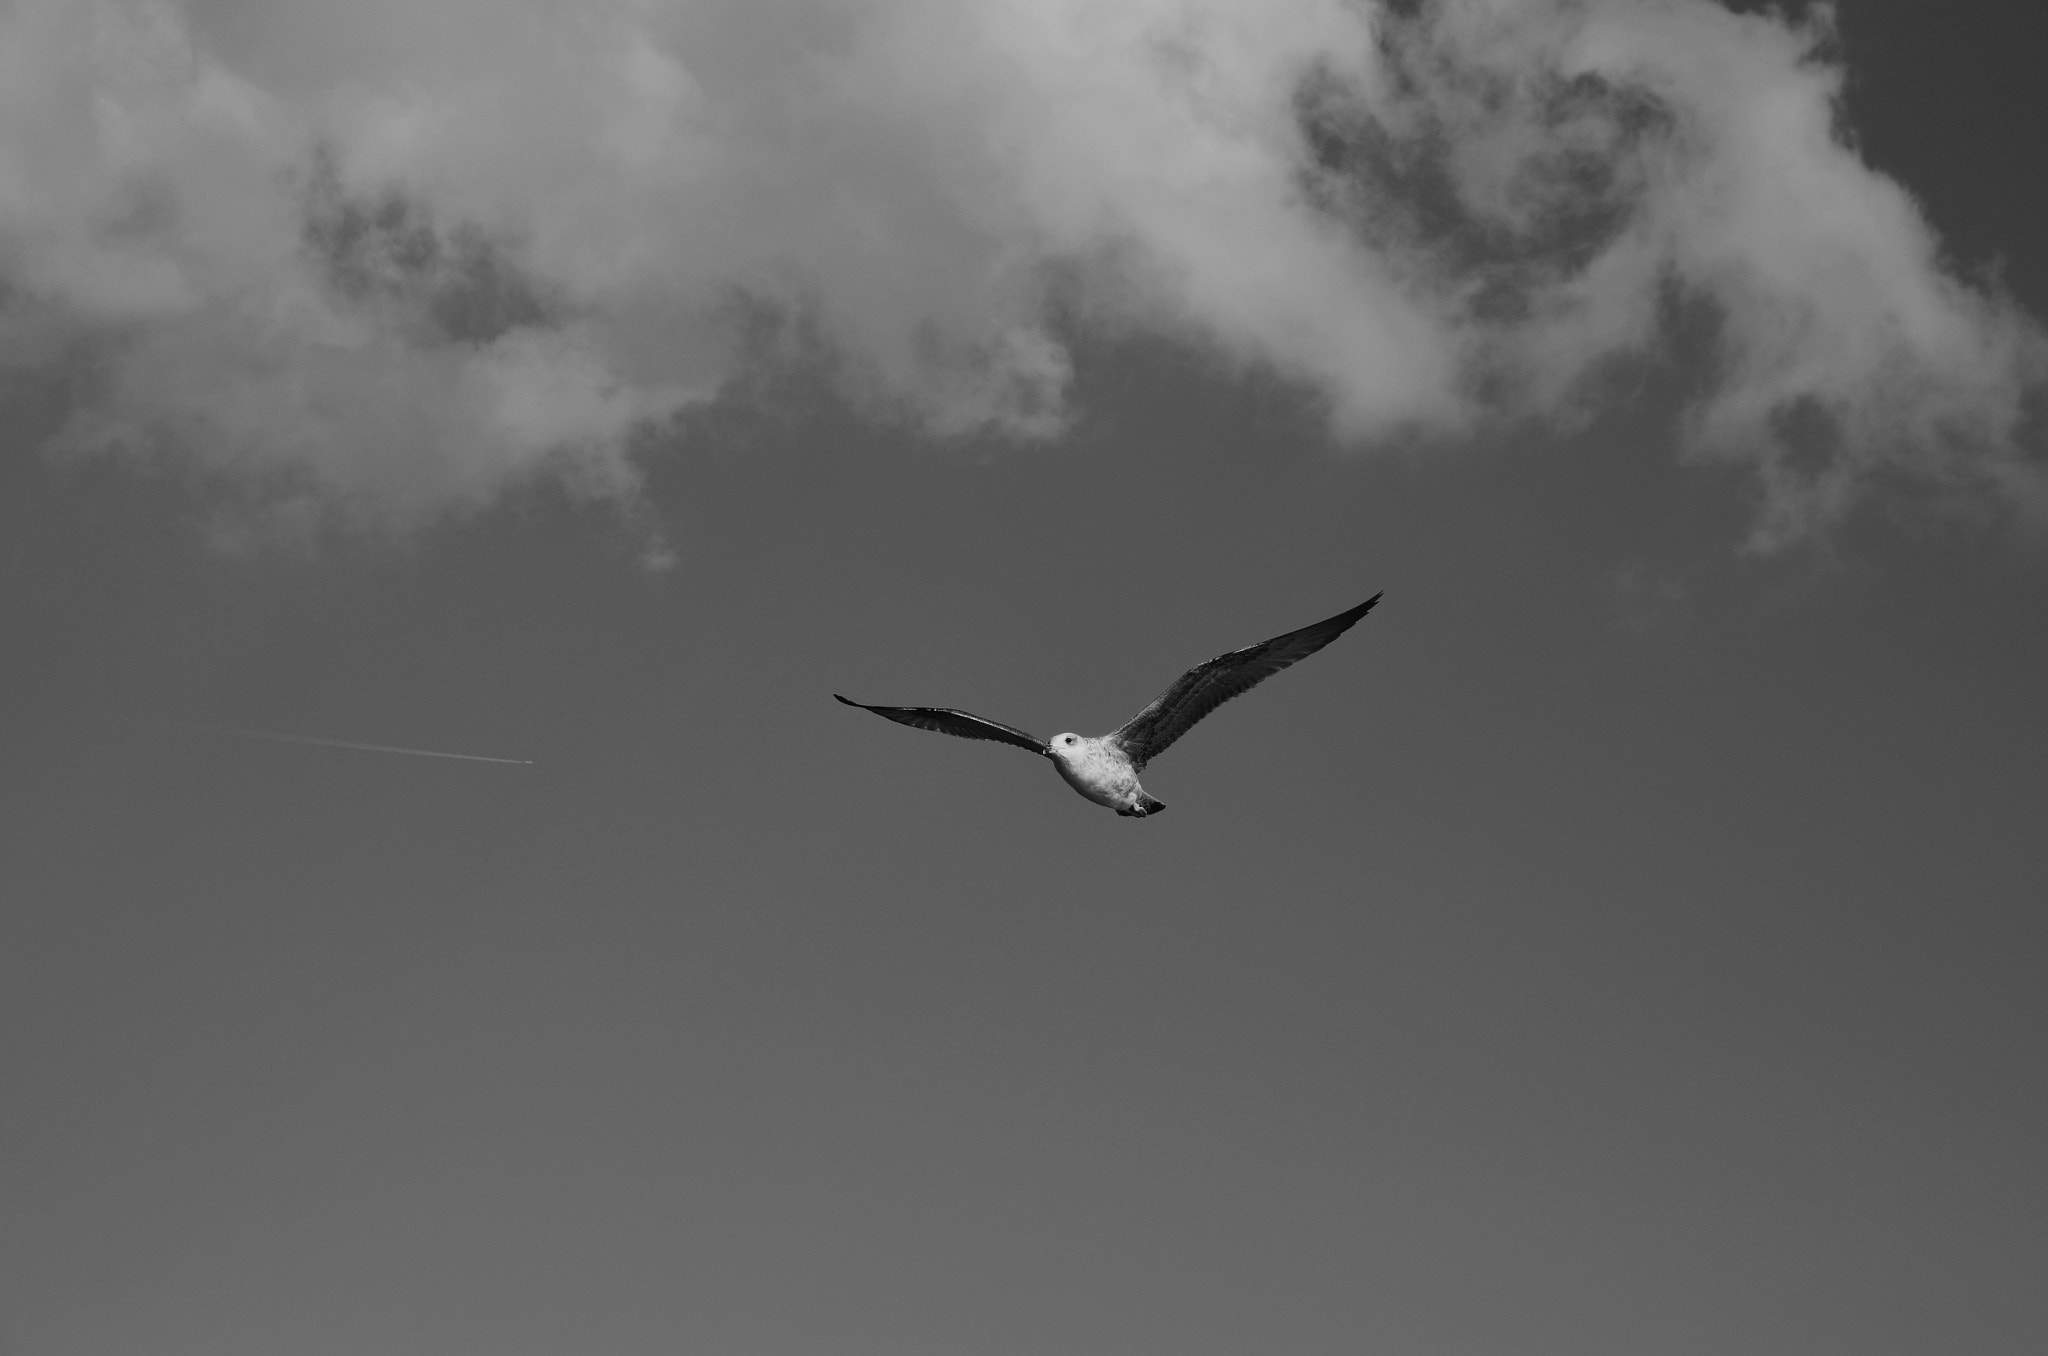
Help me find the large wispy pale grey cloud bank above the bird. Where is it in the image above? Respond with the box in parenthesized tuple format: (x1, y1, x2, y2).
(0, 0, 2048, 549)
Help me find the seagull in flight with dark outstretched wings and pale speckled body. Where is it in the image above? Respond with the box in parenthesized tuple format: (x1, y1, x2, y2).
(834, 594, 1382, 819)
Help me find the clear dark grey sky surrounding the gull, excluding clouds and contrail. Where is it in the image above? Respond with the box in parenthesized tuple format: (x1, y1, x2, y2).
(0, 0, 2048, 1356)
